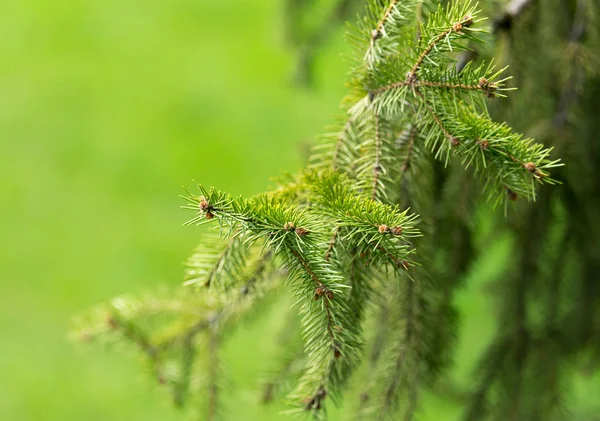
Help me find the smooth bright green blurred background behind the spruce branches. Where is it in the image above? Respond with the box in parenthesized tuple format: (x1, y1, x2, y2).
(0, 0, 598, 421)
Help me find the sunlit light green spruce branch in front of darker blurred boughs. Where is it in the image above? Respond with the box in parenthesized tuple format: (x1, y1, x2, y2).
(75, 0, 568, 421)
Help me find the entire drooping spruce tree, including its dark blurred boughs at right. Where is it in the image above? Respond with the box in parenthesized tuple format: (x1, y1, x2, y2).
(75, 0, 600, 420)
